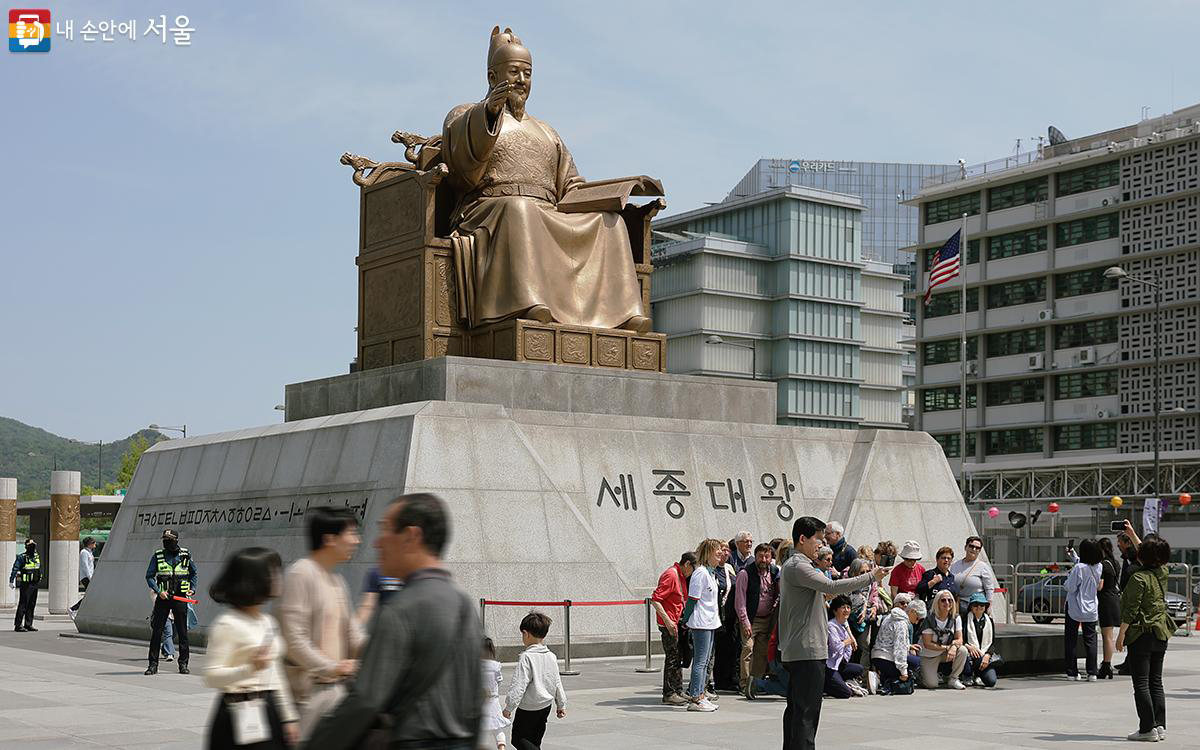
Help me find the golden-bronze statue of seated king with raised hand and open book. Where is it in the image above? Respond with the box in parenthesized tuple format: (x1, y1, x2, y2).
(342, 26, 665, 370)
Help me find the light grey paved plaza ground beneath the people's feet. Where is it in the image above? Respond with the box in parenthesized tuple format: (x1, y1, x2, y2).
(0, 609, 1200, 750)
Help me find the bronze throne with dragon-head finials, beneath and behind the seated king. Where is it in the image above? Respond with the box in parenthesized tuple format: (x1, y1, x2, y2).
(342, 132, 666, 372)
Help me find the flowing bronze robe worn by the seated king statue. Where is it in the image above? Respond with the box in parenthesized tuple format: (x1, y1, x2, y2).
(443, 102, 646, 328)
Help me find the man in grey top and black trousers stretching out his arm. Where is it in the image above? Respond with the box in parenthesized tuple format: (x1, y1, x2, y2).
(779, 516, 890, 750)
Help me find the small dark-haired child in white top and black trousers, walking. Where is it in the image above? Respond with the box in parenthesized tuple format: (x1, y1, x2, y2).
(504, 612, 566, 750)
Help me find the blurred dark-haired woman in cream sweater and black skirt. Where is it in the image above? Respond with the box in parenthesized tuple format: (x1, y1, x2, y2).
(204, 547, 300, 750)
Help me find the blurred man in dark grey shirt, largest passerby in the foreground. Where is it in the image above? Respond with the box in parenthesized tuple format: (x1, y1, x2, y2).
(306, 493, 484, 750)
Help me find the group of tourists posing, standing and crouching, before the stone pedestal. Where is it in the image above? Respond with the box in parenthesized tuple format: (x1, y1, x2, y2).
(650, 523, 1000, 712)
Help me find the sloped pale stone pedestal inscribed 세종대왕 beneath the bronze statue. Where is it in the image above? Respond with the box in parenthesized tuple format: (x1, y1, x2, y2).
(76, 358, 973, 653)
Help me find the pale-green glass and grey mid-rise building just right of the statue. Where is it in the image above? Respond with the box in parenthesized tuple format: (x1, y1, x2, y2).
(650, 186, 912, 428)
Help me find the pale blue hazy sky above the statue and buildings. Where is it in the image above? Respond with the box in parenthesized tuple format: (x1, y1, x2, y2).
(0, 0, 1200, 440)
